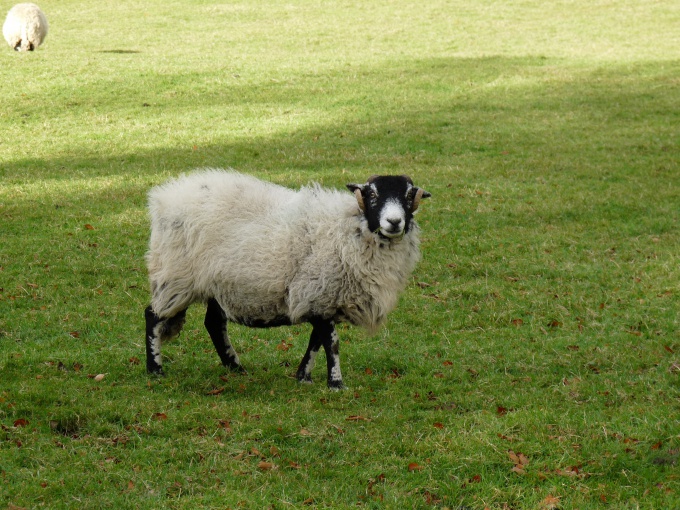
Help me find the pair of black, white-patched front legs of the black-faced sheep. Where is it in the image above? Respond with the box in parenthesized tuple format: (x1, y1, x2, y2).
(297, 320, 345, 390)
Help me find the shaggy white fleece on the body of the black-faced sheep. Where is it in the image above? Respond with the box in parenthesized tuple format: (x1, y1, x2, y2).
(146, 169, 420, 329)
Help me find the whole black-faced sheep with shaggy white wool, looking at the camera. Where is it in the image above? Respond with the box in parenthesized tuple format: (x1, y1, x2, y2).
(145, 169, 431, 389)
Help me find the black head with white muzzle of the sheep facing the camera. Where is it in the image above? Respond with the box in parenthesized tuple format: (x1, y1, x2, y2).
(347, 175, 431, 239)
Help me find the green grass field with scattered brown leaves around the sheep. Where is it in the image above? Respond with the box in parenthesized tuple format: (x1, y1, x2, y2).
(0, 0, 680, 509)
